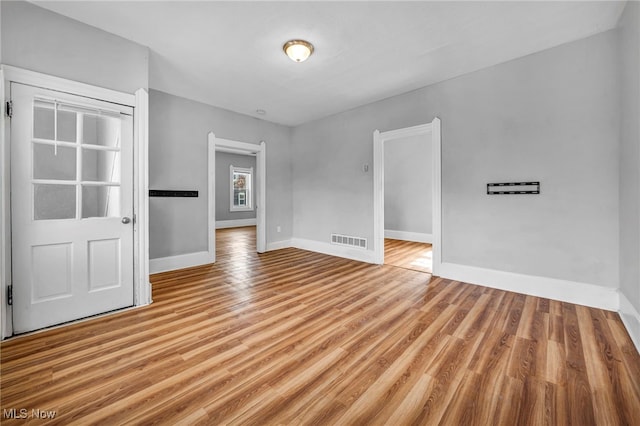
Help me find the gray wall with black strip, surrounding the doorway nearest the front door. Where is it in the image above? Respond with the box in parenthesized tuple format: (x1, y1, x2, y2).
(149, 90, 292, 259)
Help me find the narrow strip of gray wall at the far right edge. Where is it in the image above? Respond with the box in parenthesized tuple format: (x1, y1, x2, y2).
(619, 2, 640, 316)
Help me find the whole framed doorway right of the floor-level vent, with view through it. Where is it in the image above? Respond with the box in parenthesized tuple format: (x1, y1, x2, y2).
(374, 118, 442, 275)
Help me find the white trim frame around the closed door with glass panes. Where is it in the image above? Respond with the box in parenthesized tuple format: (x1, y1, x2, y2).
(0, 65, 151, 339)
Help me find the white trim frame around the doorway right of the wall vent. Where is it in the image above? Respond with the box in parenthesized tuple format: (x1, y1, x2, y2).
(373, 117, 442, 276)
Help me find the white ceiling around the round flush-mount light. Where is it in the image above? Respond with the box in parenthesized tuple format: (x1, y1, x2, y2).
(34, 1, 624, 125)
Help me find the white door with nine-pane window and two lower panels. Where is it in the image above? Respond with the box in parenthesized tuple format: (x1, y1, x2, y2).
(10, 83, 133, 333)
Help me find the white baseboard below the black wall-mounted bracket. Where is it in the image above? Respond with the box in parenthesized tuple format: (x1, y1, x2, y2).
(440, 262, 620, 311)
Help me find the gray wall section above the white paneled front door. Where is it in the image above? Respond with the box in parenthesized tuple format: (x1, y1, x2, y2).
(0, 1, 149, 93)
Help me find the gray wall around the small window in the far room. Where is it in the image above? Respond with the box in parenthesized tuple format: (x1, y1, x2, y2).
(216, 152, 258, 220)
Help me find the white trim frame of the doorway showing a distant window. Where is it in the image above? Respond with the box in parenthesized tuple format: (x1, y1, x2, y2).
(208, 132, 267, 262)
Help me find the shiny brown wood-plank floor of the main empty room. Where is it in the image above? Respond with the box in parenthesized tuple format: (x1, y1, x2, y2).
(0, 228, 640, 426)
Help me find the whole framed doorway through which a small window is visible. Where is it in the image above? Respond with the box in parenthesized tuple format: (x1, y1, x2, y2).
(209, 133, 266, 262)
